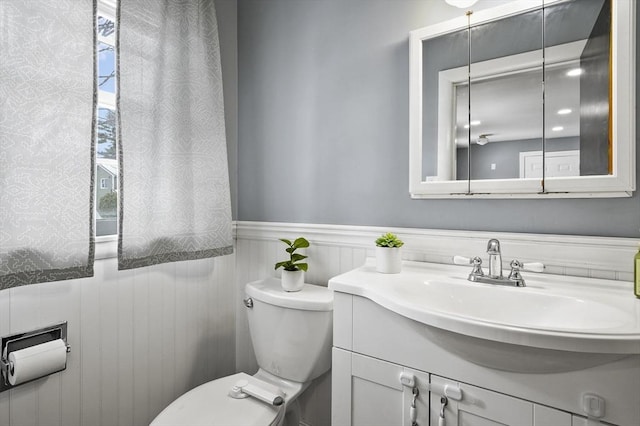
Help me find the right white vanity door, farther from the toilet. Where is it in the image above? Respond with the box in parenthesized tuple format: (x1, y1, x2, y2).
(431, 375, 571, 426)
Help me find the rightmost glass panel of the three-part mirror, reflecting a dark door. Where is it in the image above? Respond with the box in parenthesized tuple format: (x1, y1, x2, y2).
(544, 0, 613, 177)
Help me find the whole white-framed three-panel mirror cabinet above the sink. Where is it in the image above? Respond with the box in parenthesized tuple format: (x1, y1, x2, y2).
(410, 0, 635, 198)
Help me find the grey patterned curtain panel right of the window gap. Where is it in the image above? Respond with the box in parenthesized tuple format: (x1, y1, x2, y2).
(117, 0, 233, 269)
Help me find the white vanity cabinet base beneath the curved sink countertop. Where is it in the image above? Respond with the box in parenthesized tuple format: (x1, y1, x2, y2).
(332, 291, 640, 426)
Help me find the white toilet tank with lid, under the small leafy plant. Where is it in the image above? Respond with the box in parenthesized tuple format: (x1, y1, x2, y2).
(245, 278, 333, 383)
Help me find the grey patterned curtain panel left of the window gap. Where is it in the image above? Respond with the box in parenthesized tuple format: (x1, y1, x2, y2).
(0, 0, 96, 290)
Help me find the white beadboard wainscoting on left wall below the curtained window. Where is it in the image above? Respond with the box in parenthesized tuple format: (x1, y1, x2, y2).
(0, 247, 235, 426)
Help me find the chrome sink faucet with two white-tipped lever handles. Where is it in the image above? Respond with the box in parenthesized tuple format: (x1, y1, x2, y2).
(453, 238, 544, 287)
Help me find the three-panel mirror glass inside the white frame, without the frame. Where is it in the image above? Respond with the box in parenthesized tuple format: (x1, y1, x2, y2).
(422, 0, 612, 185)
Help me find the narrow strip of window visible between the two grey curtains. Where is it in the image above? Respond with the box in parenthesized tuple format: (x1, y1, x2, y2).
(95, 0, 118, 237)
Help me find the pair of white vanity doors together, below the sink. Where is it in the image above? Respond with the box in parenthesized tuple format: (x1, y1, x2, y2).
(332, 348, 572, 426)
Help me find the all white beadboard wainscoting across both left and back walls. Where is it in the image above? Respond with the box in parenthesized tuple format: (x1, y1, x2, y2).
(0, 222, 637, 426)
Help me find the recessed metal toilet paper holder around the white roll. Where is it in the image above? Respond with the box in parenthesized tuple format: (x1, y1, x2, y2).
(0, 321, 71, 392)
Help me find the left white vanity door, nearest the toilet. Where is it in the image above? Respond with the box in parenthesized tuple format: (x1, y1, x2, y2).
(331, 348, 429, 426)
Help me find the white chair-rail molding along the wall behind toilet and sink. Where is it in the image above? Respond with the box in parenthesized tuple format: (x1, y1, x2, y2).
(236, 221, 639, 281)
